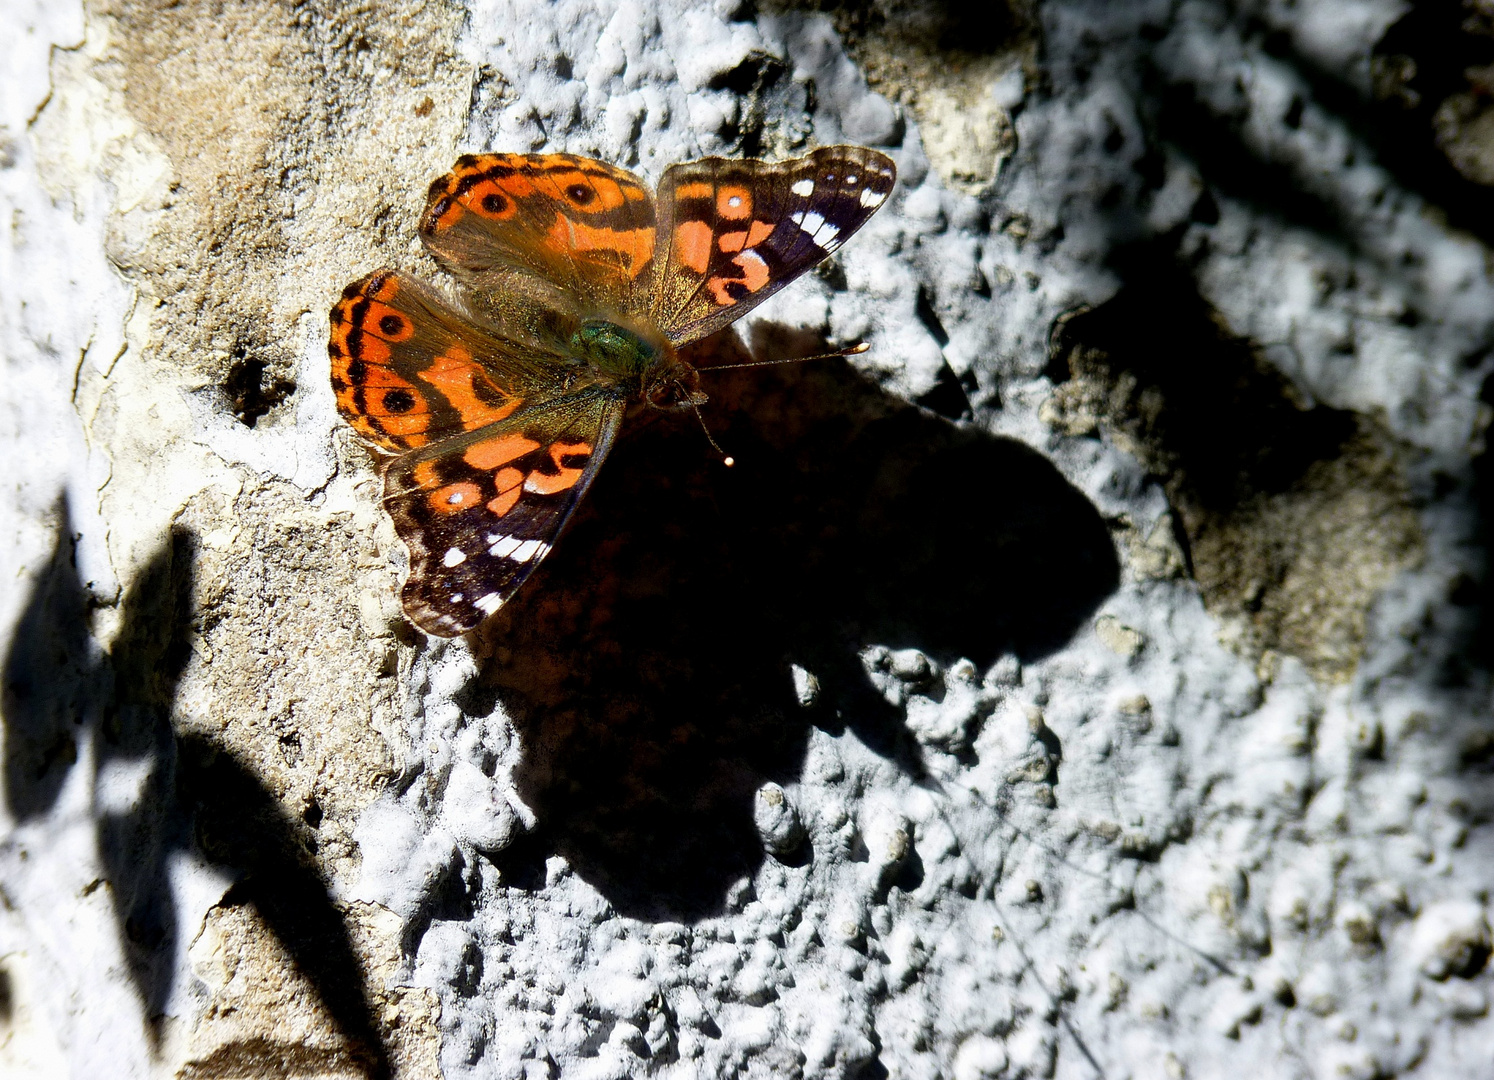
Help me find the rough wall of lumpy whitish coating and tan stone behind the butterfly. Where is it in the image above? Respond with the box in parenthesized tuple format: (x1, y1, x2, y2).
(0, 0, 1494, 1080)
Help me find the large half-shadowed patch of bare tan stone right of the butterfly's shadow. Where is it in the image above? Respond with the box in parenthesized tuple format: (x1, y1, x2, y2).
(1043, 250, 1424, 683)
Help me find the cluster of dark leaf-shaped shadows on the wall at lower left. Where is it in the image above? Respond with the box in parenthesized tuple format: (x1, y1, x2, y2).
(3, 502, 388, 1077)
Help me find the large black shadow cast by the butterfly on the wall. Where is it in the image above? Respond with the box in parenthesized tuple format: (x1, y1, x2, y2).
(468, 335, 1119, 920)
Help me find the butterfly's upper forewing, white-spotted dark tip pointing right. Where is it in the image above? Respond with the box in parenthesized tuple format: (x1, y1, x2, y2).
(653, 146, 896, 345)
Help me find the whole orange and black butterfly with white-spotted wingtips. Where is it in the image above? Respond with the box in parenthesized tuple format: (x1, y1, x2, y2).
(327, 146, 896, 638)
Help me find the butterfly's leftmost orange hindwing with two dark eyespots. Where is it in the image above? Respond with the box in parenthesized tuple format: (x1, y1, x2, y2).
(327, 270, 564, 453)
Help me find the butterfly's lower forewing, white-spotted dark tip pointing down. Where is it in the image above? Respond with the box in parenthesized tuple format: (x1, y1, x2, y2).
(384, 390, 623, 638)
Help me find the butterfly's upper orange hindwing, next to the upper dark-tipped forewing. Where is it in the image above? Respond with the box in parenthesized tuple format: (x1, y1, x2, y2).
(420, 154, 656, 314)
